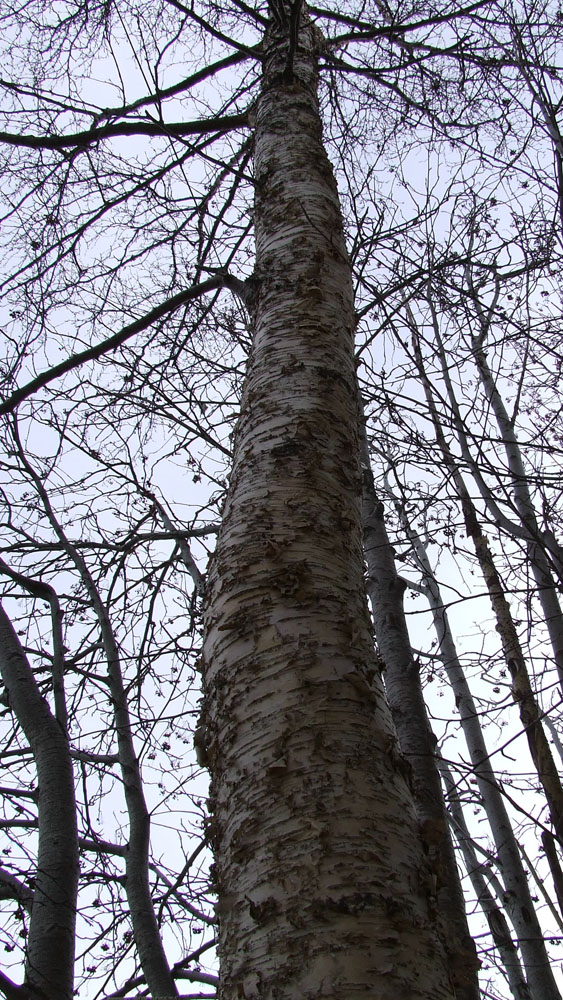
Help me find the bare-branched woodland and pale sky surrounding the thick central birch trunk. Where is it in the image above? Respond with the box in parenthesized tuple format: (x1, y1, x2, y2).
(0, 0, 563, 1000)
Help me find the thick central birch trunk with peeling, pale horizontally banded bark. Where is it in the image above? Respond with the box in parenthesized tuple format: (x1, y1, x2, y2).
(198, 4, 455, 1000)
